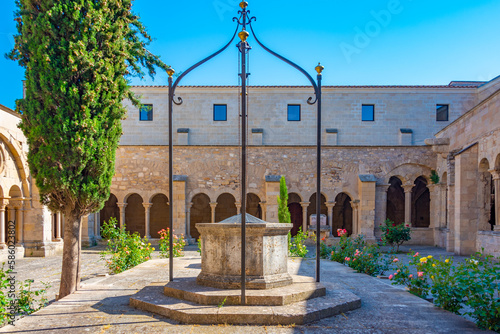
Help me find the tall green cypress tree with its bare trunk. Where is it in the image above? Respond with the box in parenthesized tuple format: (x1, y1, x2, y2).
(8, 0, 167, 298)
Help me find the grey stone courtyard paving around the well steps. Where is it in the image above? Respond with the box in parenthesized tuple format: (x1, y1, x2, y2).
(0, 246, 488, 334)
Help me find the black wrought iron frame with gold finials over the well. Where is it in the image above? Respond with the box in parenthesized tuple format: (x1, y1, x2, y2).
(167, 1, 324, 305)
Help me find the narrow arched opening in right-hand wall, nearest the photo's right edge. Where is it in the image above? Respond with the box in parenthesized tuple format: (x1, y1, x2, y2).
(477, 158, 495, 231)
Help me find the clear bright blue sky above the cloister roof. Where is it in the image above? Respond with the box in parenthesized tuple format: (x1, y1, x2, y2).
(0, 0, 500, 108)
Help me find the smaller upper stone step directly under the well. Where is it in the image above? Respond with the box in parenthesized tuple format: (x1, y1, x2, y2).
(163, 276, 326, 306)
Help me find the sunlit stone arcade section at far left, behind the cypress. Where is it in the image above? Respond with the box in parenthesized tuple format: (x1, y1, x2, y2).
(0, 105, 62, 261)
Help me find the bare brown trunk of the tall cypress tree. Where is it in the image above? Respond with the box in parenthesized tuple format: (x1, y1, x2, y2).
(59, 214, 82, 298)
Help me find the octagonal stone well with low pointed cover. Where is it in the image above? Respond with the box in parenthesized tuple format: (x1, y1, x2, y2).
(196, 214, 293, 289)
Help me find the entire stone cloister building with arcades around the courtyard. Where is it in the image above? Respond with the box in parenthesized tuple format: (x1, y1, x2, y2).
(0, 78, 500, 255)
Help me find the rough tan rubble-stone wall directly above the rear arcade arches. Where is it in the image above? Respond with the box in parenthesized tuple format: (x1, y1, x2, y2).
(107, 146, 435, 237)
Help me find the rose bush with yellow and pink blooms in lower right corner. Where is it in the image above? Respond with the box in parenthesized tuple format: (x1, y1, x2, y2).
(389, 253, 500, 332)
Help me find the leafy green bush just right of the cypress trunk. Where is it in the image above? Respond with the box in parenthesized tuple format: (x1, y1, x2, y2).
(100, 217, 154, 274)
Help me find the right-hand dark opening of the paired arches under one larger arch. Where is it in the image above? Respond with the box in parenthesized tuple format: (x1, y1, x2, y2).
(411, 176, 431, 227)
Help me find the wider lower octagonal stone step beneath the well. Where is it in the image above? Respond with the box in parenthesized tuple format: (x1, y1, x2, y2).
(130, 283, 361, 325)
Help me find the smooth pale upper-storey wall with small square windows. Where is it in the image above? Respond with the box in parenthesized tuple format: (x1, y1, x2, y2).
(120, 86, 477, 146)
